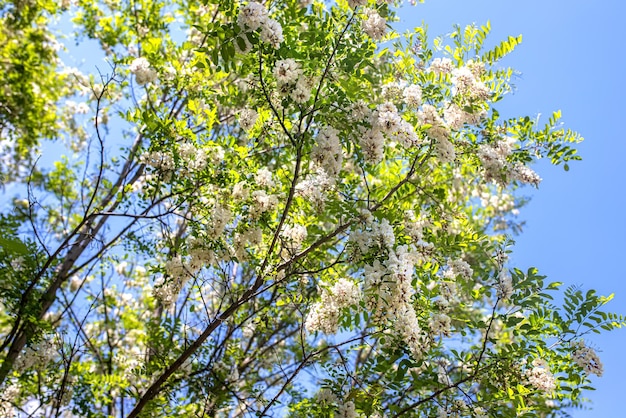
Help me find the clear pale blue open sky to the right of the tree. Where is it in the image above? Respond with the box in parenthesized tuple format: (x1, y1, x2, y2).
(400, 0, 626, 418)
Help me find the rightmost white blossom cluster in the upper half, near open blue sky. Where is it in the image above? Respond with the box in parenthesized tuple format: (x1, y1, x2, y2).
(478, 138, 541, 186)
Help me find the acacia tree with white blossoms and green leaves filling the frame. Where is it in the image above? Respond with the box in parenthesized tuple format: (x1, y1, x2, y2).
(0, 0, 624, 417)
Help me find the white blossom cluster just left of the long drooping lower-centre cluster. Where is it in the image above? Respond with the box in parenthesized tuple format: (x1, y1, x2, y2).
(304, 278, 361, 334)
